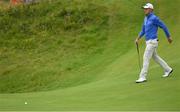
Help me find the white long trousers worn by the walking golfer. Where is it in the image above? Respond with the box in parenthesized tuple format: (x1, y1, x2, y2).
(140, 39, 171, 78)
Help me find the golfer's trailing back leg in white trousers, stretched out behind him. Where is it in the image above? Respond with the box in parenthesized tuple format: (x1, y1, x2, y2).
(153, 49, 172, 74)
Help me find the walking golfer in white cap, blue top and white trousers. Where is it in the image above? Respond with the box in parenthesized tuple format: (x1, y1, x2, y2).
(135, 3, 173, 83)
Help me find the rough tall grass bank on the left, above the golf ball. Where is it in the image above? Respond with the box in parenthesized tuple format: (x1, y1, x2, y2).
(0, 0, 109, 93)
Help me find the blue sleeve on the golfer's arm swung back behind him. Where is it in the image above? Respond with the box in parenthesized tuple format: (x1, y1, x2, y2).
(154, 17, 170, 38)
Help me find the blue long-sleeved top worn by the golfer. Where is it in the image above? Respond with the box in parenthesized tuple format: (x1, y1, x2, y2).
(139, 13, 170, 41)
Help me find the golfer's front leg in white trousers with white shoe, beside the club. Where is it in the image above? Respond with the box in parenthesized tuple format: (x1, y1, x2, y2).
(136, 44, 155, 83)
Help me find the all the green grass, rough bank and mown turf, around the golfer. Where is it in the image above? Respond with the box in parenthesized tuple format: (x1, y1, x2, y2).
(0, 0, 180, 111)
